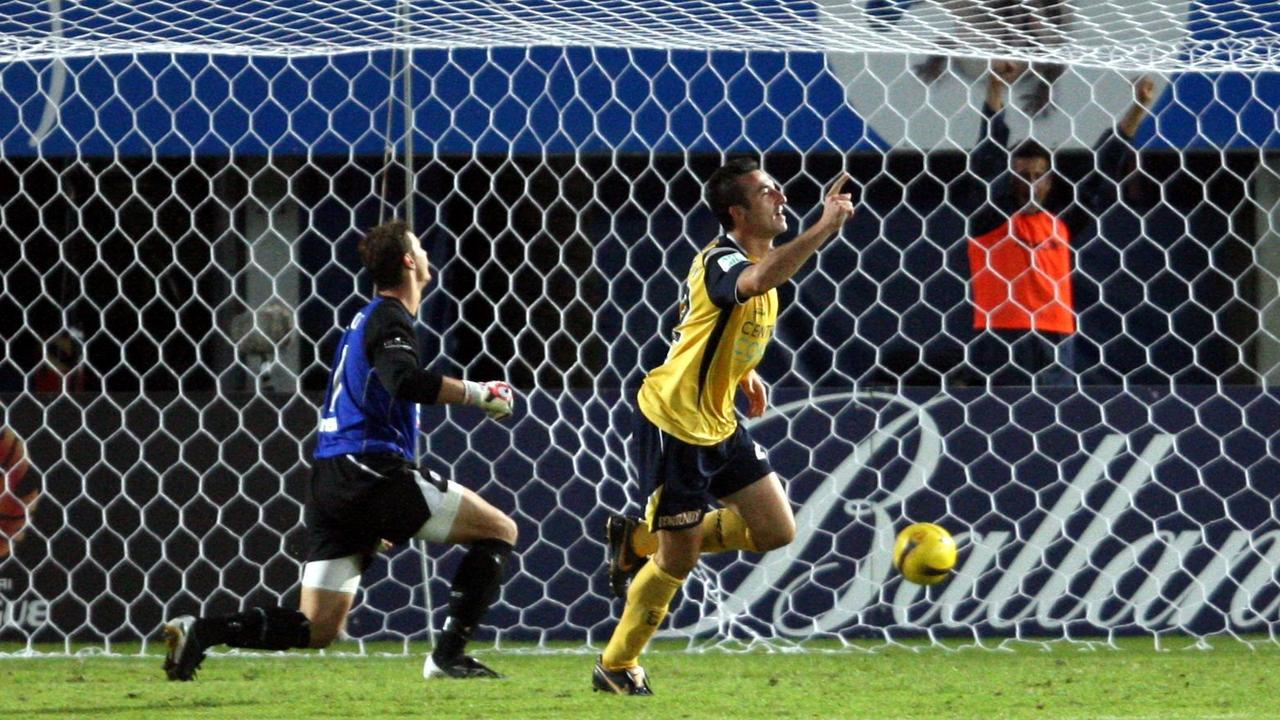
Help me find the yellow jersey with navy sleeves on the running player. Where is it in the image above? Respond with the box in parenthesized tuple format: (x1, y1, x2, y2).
(639, 236, 778, 446)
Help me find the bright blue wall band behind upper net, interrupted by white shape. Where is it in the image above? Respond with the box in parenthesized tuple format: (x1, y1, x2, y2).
(0, 47, 1280, 156)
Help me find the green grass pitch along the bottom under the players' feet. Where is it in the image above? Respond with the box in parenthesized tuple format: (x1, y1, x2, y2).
(0, 638, 1280, 720)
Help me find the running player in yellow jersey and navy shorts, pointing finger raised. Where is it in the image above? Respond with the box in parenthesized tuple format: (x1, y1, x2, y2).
(591, 159, 854, 694)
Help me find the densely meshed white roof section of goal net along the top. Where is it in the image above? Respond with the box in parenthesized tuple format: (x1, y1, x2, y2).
(0, 0, 1277, 70)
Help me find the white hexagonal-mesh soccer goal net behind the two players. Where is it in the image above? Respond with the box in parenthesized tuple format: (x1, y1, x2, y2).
(0, 0, 1280, 651)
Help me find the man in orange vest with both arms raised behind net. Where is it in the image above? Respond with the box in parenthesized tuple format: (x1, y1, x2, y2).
(969, 60, 1155, 386)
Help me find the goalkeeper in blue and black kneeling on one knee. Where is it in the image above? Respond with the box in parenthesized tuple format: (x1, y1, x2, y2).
(164, 220, 516, 680)
